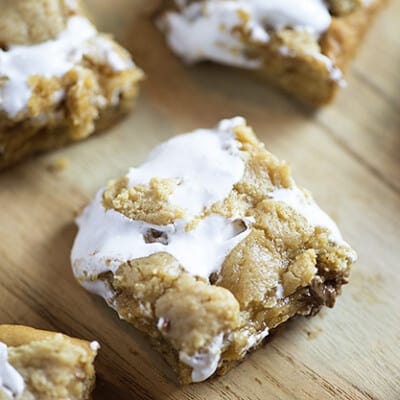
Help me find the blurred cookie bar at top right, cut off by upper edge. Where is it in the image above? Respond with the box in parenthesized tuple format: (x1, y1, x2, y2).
(158, 0, 385, 105)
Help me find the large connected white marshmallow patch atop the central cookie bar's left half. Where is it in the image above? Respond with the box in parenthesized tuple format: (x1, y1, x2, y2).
(72, 118, 251, 280)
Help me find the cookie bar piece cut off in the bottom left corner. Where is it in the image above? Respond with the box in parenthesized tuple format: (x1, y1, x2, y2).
(0, 325, 99, 400)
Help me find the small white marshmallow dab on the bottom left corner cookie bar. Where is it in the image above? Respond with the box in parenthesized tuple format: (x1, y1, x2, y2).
(0, 342, 25, 398)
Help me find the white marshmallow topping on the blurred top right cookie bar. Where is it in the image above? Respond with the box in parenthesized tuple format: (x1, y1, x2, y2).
(158, 0, 344, 84)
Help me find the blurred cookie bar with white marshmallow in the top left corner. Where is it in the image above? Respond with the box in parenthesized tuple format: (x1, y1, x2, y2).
(0, 0, 143, 169)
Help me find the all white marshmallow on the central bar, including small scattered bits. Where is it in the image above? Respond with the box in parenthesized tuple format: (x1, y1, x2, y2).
(71, 117, 355, 382)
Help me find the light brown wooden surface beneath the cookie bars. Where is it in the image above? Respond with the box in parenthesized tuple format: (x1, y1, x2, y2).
(0, 0, 400, 400)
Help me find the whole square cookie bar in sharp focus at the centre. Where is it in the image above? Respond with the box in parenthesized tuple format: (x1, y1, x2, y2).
(71, 117, 356, 384)
